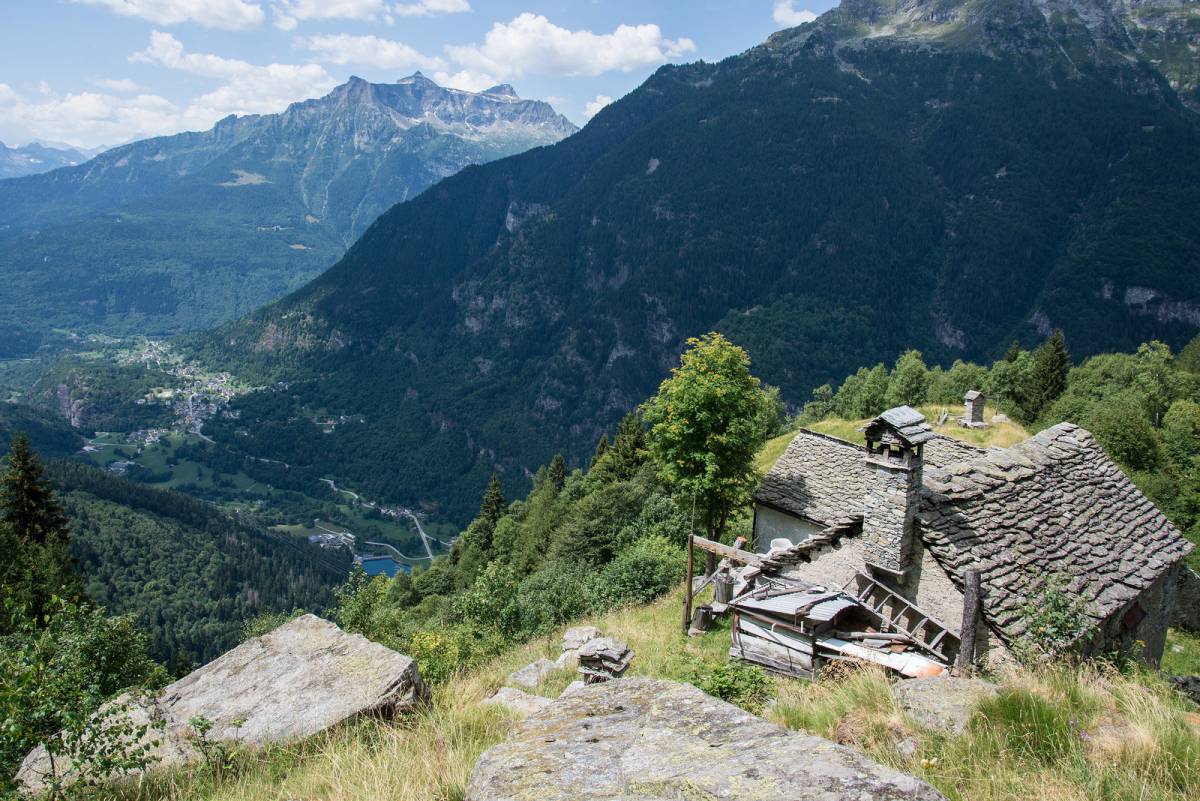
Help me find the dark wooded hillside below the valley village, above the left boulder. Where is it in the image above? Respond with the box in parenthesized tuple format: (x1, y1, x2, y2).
(47, 460, 350, 668)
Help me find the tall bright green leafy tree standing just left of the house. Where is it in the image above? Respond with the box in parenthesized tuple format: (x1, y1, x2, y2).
(643, 333, 770, 538)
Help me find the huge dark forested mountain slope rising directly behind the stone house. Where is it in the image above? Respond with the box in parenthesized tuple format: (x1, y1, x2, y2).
(187, 0, 1200, 518)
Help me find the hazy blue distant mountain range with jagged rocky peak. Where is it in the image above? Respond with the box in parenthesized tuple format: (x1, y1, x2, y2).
(0, 73, 576, 355)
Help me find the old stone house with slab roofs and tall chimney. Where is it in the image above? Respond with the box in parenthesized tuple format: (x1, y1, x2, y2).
(754, 406, 1200, 664)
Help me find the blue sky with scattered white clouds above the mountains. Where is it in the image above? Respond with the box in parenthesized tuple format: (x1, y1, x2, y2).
(0, 0, 835, 147)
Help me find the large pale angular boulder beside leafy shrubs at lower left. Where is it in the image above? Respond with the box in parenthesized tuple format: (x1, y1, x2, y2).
(17, 615, 428, 791)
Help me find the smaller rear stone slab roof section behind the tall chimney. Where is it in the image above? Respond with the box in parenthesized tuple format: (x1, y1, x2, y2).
(755, 428, 983, 526)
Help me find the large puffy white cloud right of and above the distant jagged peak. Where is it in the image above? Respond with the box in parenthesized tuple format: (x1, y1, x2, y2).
(446, 12, 696, 80)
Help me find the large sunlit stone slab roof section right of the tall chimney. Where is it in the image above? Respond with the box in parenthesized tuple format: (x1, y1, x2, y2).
(920, 423, 1193, 640)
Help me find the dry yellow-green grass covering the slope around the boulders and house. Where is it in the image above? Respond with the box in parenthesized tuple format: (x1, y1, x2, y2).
(108, 419, 1200, 801)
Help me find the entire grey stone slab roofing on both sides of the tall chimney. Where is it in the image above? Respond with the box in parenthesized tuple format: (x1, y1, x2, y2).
(755, 423, 1193, 642)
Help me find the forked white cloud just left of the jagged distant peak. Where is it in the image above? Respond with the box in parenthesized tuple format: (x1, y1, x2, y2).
(130, 31, 337, 121)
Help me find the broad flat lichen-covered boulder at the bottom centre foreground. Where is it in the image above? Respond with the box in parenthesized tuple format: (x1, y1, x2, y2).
(467, 679, 944, 801)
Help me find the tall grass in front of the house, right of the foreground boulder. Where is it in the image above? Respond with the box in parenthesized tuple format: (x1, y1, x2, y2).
(774, 664, 1200, 801)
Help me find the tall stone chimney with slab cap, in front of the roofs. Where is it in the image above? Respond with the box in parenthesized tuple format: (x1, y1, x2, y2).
(863, 406, 935, 579)
